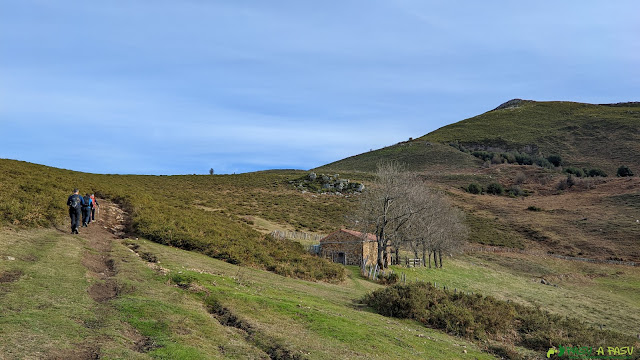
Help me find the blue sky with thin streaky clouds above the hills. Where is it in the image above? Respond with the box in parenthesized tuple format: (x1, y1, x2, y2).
(0, 0, 640, 174)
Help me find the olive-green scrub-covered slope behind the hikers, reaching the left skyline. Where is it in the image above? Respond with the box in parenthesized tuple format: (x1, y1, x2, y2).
(0, 160, 349, 281)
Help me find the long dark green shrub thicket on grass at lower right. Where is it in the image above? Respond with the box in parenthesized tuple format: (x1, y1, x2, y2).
(363, 282, 636, 358)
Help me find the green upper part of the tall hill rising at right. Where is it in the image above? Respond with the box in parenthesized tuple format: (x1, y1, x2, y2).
(319, 99, 640, 174)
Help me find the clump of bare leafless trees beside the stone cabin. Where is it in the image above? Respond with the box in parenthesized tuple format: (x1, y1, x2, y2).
(356, 162, 466, 268)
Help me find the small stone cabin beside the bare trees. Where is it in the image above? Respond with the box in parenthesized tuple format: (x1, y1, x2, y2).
(320, 229, 389, 265)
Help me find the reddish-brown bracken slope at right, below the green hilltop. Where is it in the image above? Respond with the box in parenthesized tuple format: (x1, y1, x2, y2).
(450, 172, 640, 262)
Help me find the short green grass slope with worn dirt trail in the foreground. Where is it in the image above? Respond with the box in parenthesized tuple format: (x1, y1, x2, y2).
(0, 230, 492, 360)
